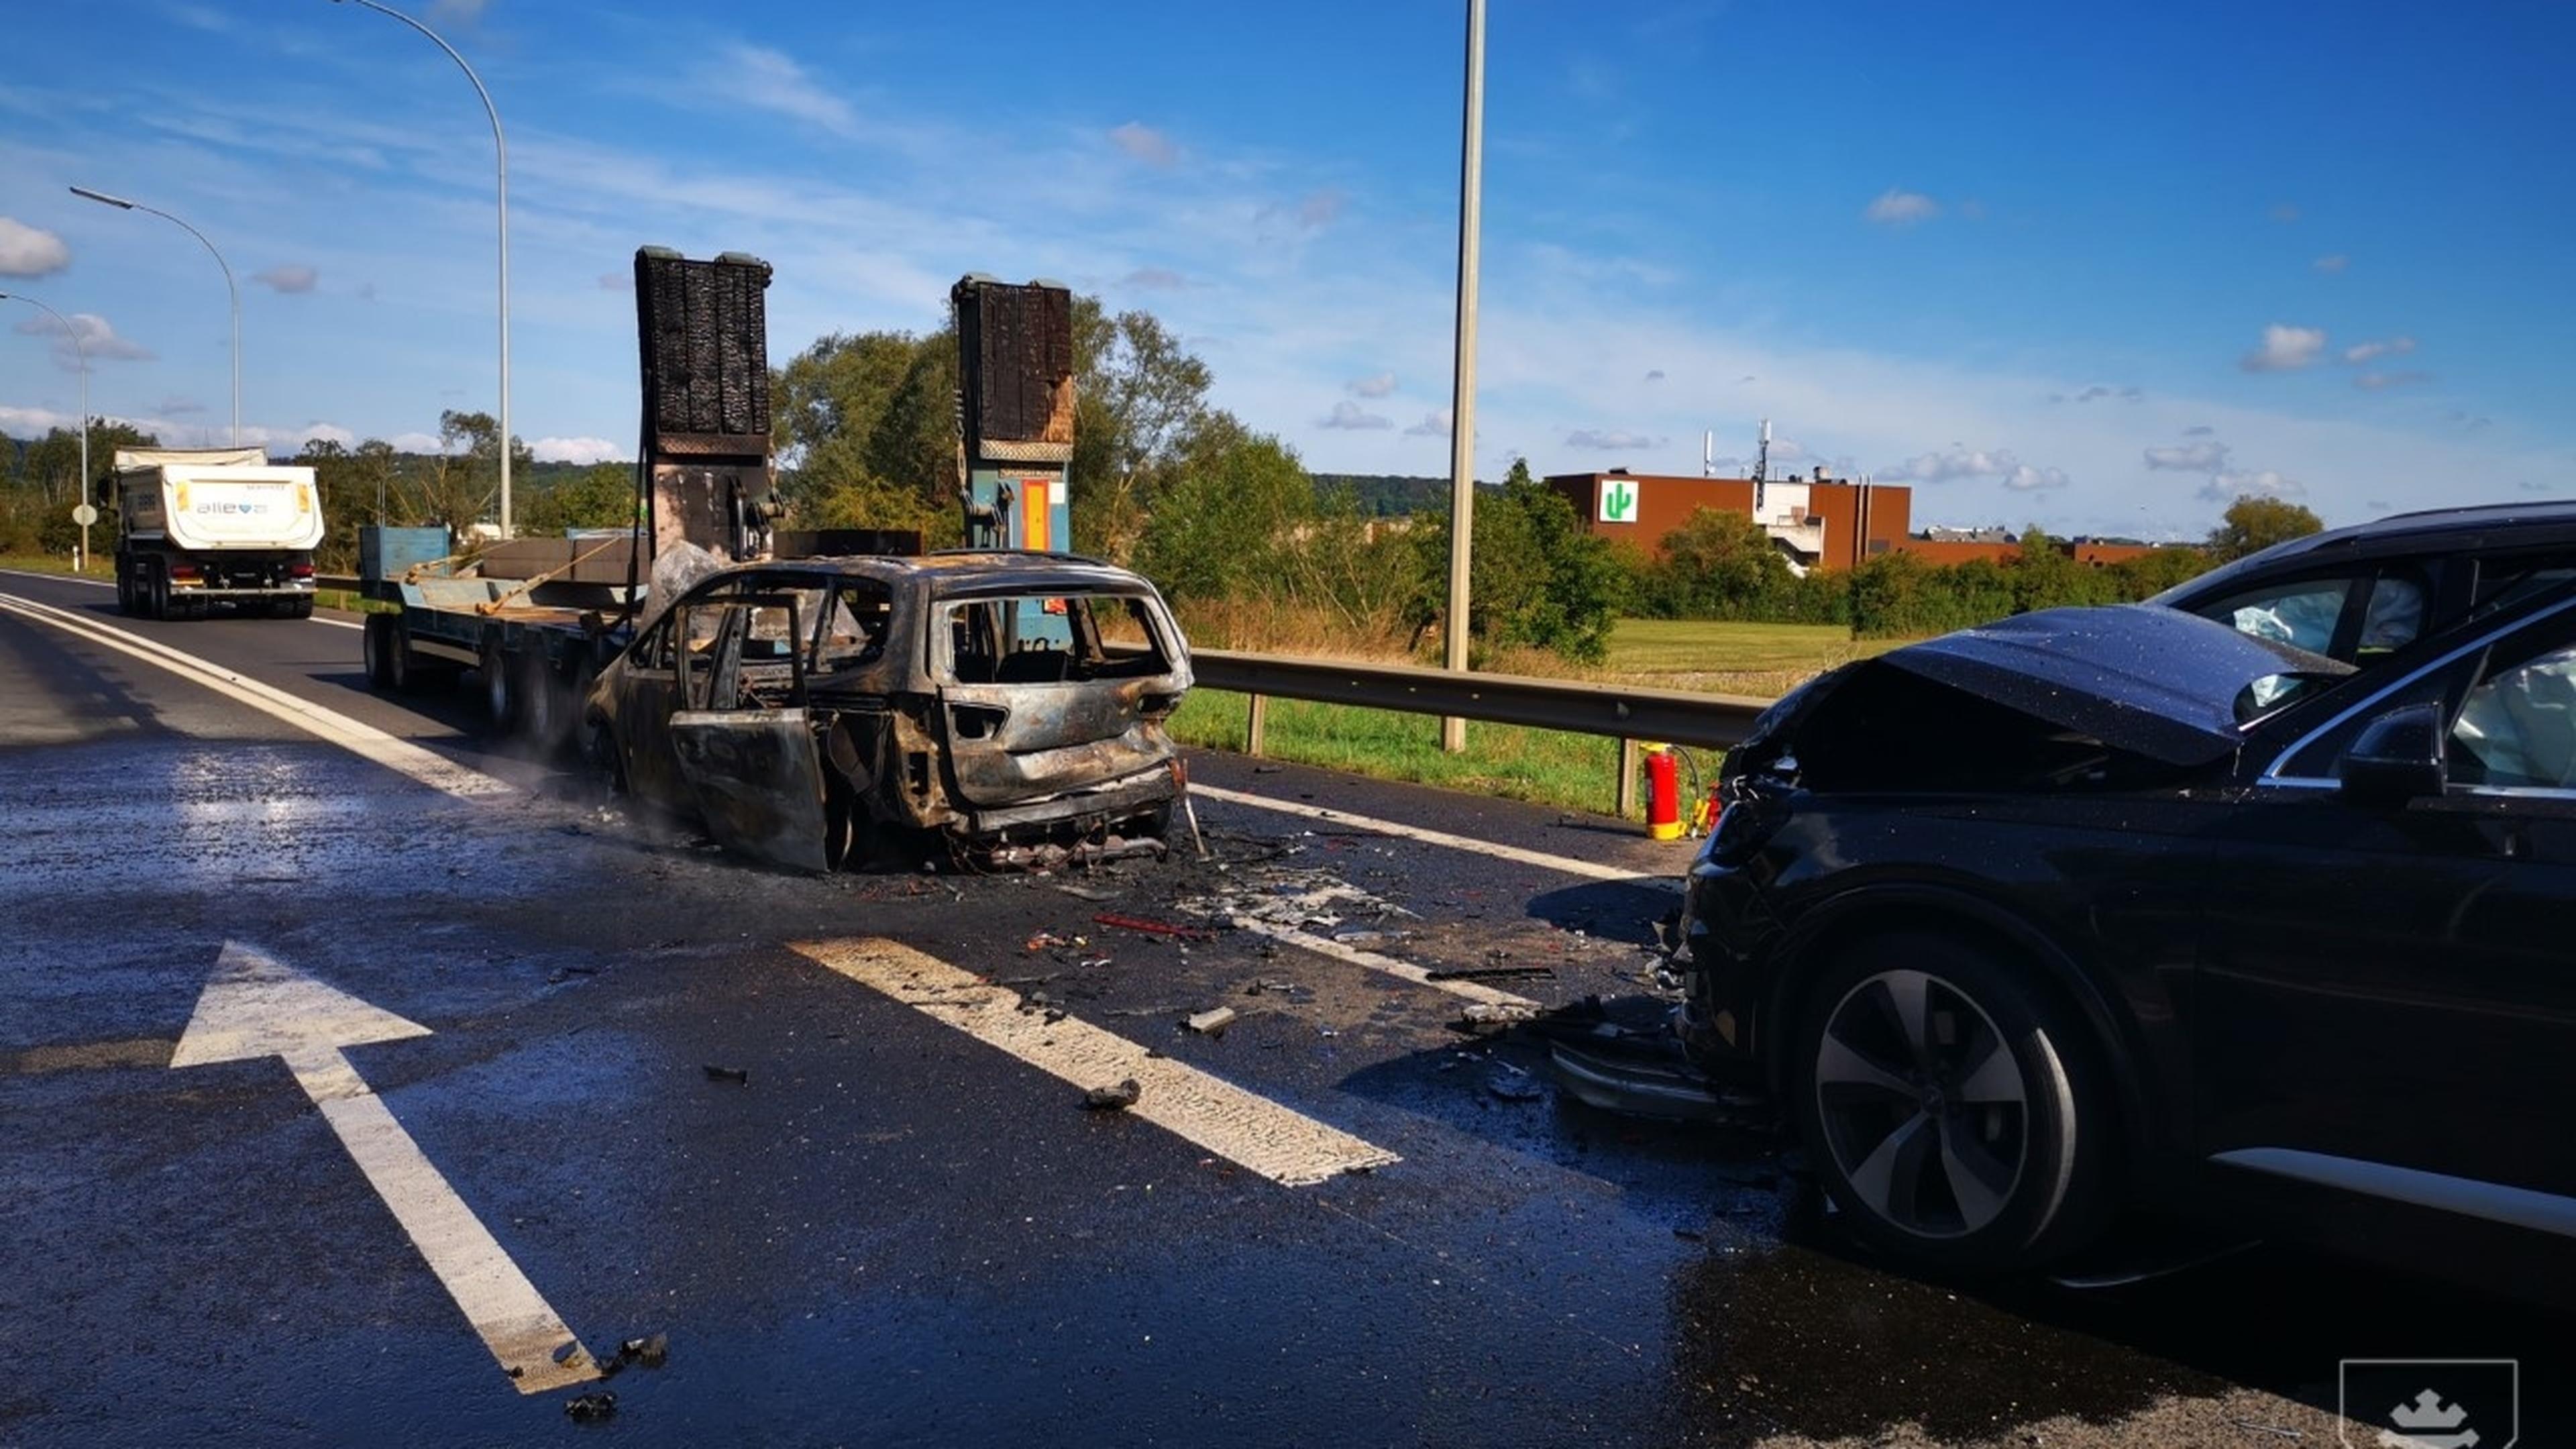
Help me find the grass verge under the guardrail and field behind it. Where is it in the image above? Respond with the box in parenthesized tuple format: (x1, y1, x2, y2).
(1172, 608, 1893, 815)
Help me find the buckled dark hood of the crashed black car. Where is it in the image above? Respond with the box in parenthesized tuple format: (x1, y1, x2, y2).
(1860, 603, 2352, 765)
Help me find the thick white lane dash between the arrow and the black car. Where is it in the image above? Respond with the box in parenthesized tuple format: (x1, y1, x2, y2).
(794, 938, 1401, 1186)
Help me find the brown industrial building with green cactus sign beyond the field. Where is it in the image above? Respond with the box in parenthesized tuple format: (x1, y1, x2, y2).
(1546, 470, 2153, 572)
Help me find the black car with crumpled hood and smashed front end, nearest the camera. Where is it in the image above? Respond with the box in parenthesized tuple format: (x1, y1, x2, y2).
(1682, 588, 2576, 1276)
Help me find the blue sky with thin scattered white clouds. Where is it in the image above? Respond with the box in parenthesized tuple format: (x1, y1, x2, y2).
(0, 0, 2576, 536)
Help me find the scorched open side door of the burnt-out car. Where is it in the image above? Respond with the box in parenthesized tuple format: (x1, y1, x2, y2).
(669, 709, 832, 871)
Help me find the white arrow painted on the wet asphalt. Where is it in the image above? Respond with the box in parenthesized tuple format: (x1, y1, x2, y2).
(170, 941, 600, 1395)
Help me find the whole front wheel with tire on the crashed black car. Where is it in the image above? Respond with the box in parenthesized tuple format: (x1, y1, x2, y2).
(1790, 933, 2117, 1274)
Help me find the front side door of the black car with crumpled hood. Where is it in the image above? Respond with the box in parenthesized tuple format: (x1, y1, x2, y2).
(2190, 596, 2576, 1235)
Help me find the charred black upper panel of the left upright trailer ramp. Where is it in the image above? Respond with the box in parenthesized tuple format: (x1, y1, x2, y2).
(636, 248, 770, 456)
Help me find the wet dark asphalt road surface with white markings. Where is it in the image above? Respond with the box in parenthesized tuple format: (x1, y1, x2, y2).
(0, 575, 2576, 1449)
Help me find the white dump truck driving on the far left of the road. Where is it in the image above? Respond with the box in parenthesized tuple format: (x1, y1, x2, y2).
(116, 449, 322, 619)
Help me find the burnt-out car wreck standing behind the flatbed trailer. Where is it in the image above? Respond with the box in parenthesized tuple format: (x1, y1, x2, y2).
(585, 551, 1190, 871)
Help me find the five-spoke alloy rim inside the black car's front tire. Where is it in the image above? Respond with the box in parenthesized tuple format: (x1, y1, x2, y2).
(1816, 969, 2030, 1238)
